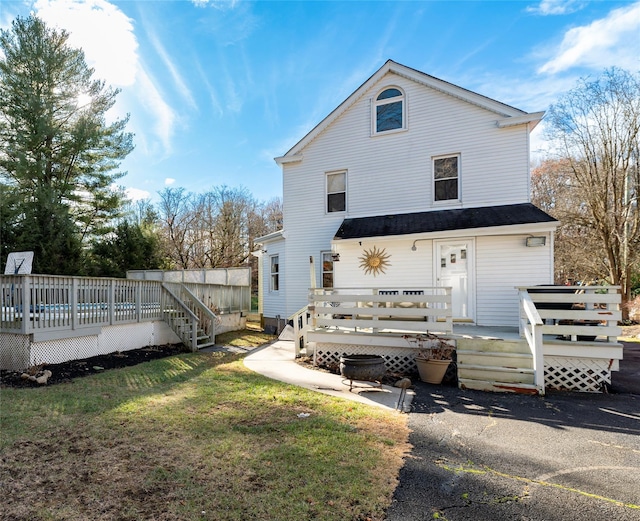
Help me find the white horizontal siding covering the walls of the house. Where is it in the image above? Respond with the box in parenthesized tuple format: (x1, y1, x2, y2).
(272, 74, 548, 319)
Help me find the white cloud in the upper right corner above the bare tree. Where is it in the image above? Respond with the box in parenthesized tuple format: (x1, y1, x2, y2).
(538, 2, 640, 74)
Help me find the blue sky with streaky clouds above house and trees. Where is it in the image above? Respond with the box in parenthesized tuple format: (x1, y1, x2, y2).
(0, 0, 640, 201)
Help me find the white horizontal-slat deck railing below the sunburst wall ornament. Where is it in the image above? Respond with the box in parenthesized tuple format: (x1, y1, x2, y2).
(308, 287, 453, 333)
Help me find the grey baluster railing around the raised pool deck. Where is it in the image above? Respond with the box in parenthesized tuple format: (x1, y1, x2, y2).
(0, 275, 251, 343)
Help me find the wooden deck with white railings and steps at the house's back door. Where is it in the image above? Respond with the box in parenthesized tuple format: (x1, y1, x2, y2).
(292, 286, 622, 394)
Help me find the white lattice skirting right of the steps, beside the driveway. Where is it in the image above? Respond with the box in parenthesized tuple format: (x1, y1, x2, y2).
(544, 356, 611, 393)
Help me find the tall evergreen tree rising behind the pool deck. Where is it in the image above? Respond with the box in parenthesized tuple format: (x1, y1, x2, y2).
(0, 16, 133, 274)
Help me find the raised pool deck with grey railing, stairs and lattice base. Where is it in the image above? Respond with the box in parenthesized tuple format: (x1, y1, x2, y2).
(0, 270, 251, 370)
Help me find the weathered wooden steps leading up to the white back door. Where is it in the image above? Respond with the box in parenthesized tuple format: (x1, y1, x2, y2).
(457, 338, 537, 394)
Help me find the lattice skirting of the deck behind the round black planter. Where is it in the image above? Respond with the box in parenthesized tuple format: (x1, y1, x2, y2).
(315, 342, 418, 374)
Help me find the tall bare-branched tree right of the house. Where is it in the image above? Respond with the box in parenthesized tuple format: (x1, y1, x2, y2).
(547, 68, 640, 314)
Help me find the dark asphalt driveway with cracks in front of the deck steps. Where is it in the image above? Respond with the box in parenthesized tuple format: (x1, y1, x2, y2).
(387, 344, 640, 521)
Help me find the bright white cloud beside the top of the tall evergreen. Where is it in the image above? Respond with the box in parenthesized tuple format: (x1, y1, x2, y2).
(33, 0, 138, 87)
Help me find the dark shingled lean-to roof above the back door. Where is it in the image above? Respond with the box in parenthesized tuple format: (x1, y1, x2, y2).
(334, 203, 558, 239)
